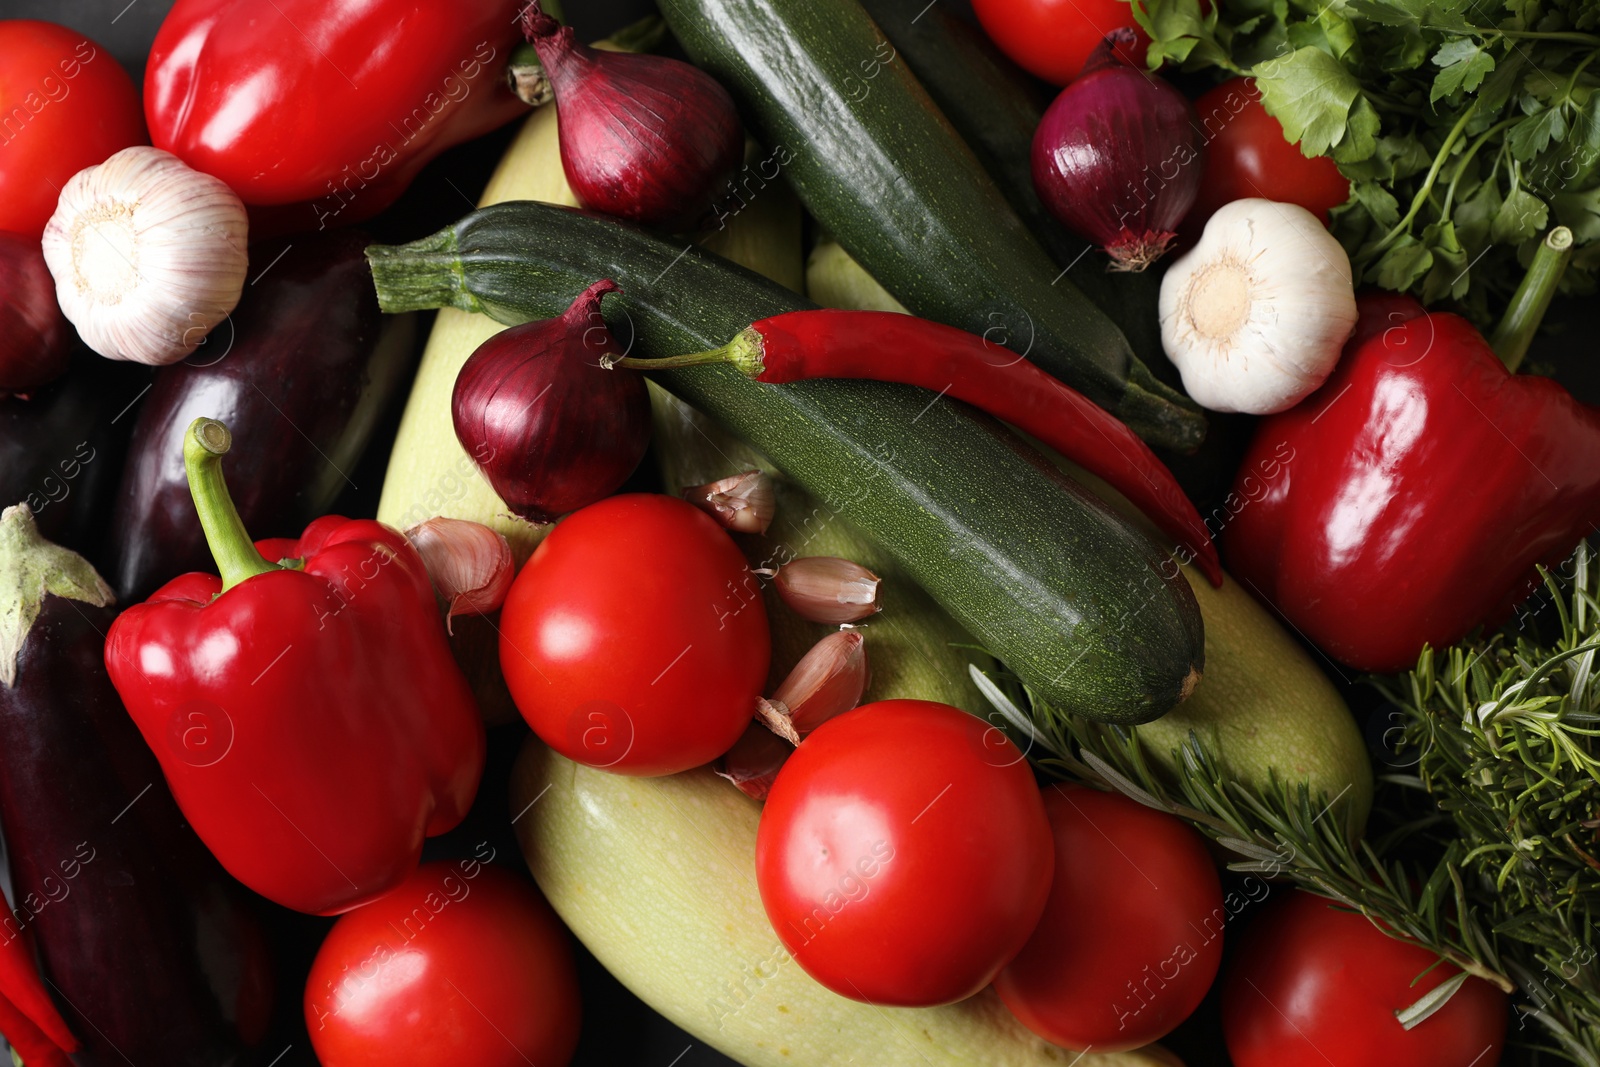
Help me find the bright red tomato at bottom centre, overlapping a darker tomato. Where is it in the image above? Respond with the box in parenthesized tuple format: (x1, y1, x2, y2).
(755, 701, 1053, 1006)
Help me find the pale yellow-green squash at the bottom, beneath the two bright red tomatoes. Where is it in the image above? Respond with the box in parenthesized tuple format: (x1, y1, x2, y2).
(512, 742, 1179, 1067)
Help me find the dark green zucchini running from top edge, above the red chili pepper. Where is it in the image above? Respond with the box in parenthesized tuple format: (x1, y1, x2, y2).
(661, 0, 1205, 450)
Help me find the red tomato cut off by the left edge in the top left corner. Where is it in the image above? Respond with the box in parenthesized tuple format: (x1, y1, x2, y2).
(0, 19, 144, 240)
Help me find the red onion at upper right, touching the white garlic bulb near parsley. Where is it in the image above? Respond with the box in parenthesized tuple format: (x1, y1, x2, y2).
(1034, 29, 1205, 270)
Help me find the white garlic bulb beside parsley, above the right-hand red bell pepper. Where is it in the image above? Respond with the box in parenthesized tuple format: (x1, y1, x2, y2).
(1162, 200, 1355, 414)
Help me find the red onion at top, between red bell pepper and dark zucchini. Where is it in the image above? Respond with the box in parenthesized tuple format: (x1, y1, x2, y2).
(523, 3, 744, 230)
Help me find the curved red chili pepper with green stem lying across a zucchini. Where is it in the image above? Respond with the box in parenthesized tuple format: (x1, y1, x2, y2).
(614, 309, 1222, 585)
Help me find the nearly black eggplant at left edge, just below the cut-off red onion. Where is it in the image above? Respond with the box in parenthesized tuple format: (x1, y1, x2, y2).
(0, 356, 150, 558)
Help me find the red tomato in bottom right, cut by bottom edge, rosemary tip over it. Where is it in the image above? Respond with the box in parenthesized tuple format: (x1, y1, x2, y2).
(1222, 889, 1507, 1067)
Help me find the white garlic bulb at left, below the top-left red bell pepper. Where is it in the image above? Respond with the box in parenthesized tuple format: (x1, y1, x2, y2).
(43, 146, 248, 365)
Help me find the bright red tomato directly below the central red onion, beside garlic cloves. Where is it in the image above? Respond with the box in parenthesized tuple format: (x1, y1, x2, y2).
(501, 493, 771, 774)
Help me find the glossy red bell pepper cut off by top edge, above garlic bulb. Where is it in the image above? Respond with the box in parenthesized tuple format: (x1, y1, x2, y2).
(144, 0, 526, 238)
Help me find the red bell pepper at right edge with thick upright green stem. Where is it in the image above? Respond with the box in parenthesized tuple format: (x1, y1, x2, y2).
(1222, 230, 1600, 672)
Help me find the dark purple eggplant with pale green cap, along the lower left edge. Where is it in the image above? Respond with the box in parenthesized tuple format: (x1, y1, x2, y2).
(0, 506, 270, 1067)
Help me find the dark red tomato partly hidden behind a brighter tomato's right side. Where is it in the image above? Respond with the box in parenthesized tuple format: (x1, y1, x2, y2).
(995, 785, 1226, 1053)
